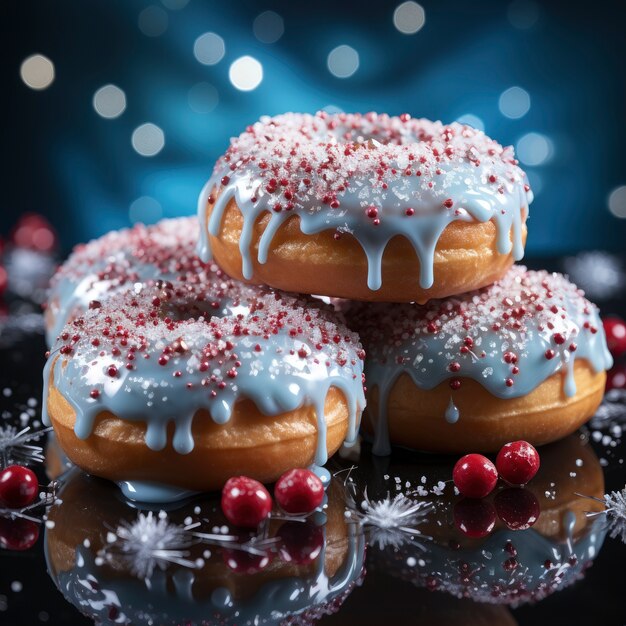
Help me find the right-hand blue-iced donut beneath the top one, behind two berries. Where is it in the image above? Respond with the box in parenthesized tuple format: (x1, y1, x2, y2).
(348, 266, 612, 454)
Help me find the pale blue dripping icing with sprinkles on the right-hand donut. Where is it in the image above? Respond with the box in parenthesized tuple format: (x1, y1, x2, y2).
(351, 266, 613, 455)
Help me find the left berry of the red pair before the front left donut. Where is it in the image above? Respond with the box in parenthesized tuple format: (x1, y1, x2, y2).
(222, 476, 272, 528)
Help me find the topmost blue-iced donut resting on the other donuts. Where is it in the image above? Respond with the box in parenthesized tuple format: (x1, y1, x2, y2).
(198, 112, 532, 302)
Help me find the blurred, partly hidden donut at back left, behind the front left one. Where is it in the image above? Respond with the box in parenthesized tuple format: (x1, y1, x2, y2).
(45, 217, 207, 346)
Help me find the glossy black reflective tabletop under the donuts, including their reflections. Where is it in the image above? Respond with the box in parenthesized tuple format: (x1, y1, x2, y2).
(0, 251, 626, 626)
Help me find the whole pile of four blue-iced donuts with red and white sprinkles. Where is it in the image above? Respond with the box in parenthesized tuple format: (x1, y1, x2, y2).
(45, 113, 610, 500)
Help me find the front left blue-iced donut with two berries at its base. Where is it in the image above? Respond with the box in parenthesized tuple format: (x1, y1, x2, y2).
(42, 268, 365, 502)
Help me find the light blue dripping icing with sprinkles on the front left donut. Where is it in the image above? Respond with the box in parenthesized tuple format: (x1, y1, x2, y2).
(43, 281, 365, 492)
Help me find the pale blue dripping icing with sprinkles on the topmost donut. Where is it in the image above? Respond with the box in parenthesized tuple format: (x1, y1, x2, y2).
(198, 114, 532, 290)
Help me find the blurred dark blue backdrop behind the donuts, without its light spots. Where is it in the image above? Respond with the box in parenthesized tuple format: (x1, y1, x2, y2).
(0, 0, 626, 254)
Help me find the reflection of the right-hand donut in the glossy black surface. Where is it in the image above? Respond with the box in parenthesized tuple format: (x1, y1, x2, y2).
(361, 435, 607, 607)
